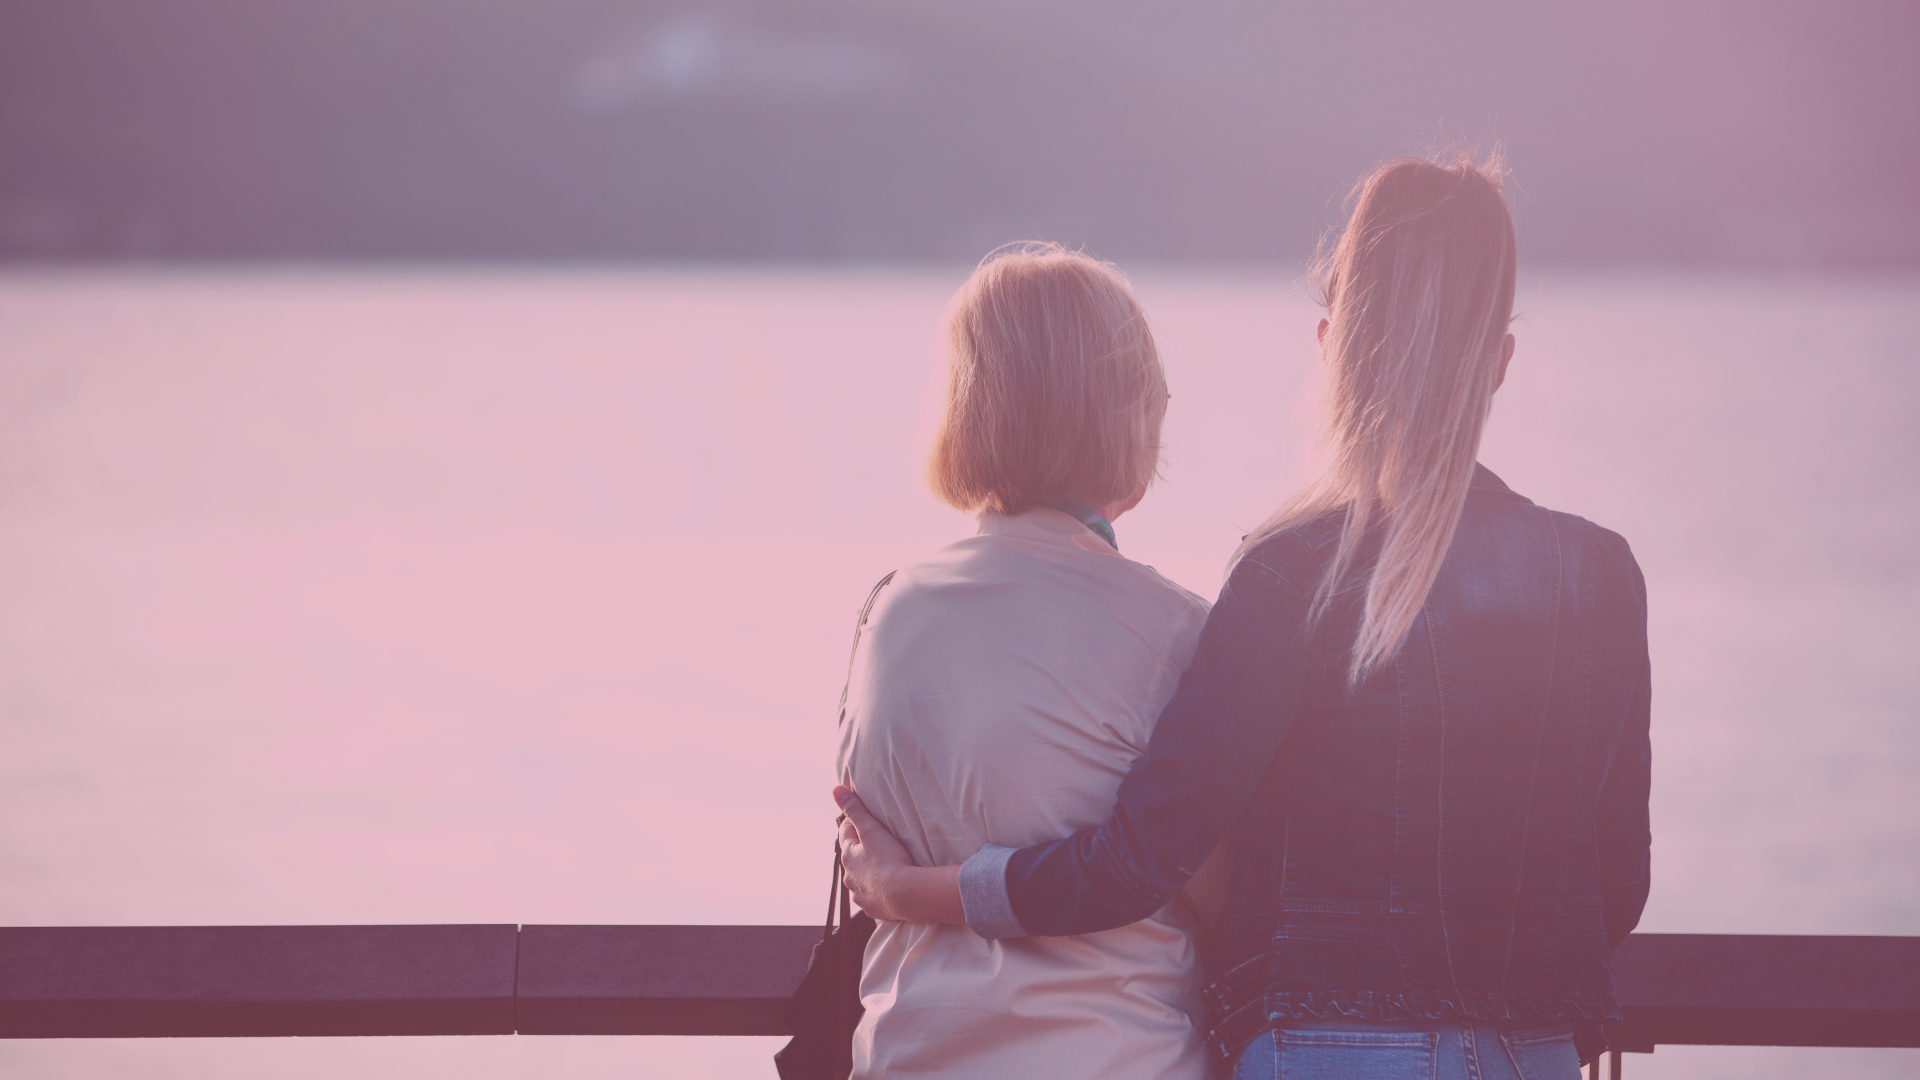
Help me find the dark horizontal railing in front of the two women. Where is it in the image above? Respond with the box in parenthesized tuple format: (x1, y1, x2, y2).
(0, 922, 1920, 1049)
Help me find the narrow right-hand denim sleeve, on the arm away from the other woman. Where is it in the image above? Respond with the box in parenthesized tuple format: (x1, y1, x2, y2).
(1594, 532, 1653, 947)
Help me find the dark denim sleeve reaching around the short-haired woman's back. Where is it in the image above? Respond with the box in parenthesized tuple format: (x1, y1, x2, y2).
(1004, 548, 1311, 936)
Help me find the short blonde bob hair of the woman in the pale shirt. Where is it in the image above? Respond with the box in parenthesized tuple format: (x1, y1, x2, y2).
(927, 244, 1167, 513)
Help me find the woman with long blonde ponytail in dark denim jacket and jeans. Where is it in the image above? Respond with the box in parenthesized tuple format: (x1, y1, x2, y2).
(835, 158, 1649, 1080)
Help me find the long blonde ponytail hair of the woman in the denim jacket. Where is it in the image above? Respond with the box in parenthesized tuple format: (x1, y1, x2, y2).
(1242, 148, 1515, 682)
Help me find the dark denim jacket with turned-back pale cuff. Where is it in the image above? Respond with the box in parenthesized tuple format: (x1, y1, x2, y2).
(962, 467, 1651, 1059)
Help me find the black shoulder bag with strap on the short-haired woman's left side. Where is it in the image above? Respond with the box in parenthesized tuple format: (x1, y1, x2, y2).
(774, 575, 893, 1080)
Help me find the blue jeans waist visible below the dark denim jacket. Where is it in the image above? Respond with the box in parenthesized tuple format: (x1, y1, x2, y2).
(1233, 1020, 1580, 1080)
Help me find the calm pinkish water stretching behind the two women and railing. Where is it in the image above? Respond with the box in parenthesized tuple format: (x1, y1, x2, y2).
(0, 269, 1920, 1080)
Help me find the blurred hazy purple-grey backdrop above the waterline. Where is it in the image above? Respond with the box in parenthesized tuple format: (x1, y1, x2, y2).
(0, 0, 1920, 263)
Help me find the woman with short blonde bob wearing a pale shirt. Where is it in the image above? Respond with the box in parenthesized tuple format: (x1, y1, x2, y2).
(839, 246, 1206, 1080)
